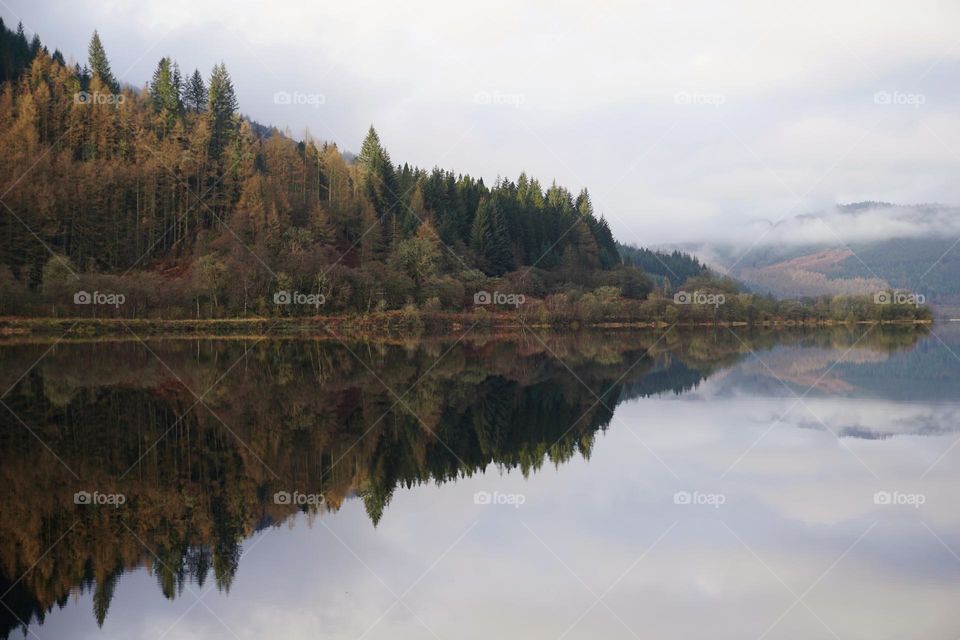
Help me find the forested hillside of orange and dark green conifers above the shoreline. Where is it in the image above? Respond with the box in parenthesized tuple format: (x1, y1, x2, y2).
(0, 23, 926, 325)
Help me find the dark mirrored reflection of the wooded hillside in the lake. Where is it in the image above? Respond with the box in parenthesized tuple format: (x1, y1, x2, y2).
(0, 329, 928, 636)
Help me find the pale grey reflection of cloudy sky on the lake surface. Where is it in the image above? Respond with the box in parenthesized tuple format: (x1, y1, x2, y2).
(31, 332, 960, 640)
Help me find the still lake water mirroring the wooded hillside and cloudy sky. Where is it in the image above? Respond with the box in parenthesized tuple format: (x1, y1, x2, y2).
(0, 325, 960, 640)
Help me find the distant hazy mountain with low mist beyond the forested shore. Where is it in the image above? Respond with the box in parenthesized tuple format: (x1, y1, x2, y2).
(680, 202, 960, 312)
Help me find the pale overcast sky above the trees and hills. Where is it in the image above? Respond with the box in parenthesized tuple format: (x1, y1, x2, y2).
(0, 0, 960, 244)
